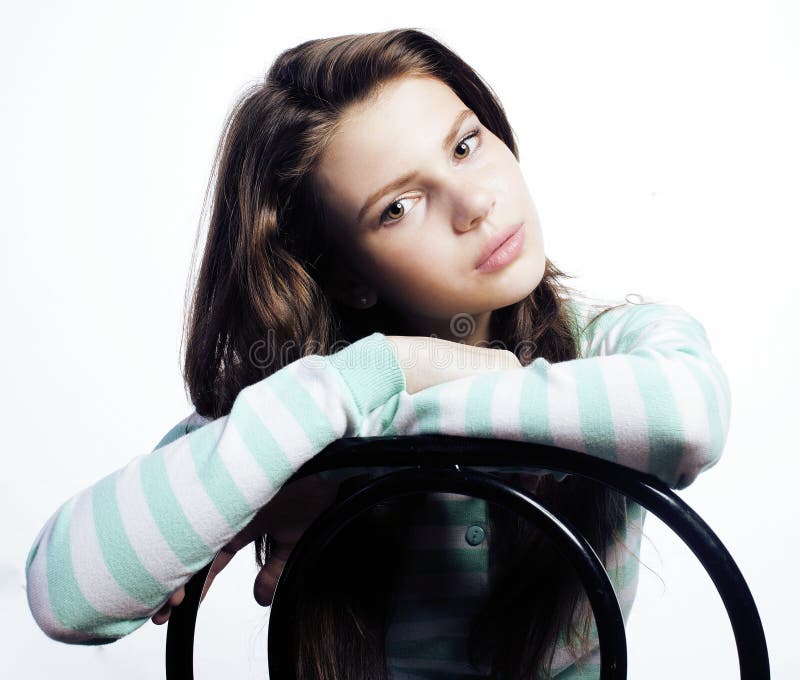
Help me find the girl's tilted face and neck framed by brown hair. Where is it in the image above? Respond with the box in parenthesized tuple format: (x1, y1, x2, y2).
(315, 76, 545, 344)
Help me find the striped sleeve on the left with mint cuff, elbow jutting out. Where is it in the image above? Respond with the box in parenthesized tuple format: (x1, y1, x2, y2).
(26, 333, 406, 644)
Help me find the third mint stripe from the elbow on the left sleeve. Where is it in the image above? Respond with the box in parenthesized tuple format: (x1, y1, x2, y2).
(139, 446, 213, 572)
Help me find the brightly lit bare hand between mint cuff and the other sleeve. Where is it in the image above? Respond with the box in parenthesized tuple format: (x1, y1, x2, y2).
(386, 335, 522, 394)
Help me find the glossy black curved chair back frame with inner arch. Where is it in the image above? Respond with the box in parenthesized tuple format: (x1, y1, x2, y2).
(166, 435, 770, 680)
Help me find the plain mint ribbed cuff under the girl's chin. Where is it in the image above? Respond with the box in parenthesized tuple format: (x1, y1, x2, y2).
(325, 333, 406, 414)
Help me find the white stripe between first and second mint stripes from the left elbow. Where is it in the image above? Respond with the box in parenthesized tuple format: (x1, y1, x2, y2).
(69, 492, 149, 619)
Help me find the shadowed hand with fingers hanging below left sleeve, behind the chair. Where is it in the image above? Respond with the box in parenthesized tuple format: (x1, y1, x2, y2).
(151, 475, 338, 625)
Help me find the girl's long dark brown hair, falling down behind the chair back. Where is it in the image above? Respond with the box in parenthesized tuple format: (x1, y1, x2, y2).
(184, 29, 625, 680)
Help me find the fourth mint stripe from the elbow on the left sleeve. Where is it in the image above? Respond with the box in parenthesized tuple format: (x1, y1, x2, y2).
(189, 423, 252, 531)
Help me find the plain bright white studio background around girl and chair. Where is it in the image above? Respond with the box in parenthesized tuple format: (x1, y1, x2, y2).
(0, 0, 800, 680)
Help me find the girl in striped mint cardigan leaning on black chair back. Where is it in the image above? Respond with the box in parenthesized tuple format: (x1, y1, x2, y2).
(27, 30, 730, 680)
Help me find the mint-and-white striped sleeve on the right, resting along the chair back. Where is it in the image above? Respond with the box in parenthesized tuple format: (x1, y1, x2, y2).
(362, 303, 731, 489)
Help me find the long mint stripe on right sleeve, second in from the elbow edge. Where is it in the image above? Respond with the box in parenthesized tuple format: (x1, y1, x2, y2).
(625, 355, 686, 485)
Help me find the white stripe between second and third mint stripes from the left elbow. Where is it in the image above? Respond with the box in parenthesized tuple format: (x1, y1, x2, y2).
(116, 456, 187, 590)
